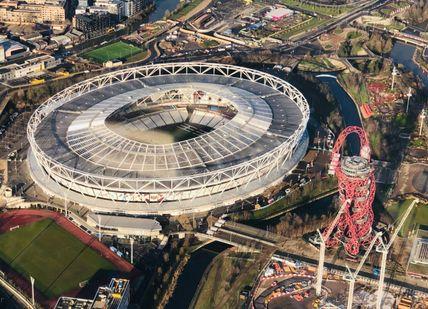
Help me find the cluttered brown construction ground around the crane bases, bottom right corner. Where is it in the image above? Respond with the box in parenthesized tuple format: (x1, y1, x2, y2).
(250, 254, 428, 309)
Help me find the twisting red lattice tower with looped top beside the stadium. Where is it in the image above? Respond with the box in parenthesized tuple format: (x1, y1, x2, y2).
(326, 126, 376, 256)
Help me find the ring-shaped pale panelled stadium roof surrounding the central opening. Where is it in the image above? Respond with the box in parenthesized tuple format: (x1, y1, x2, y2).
(36, 75, 302, 178)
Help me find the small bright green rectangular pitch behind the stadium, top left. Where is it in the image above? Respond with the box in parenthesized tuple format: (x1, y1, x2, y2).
(83, 41, 142, 63)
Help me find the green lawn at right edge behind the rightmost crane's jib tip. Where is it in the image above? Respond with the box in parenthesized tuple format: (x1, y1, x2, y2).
(387, 199, 428, 237)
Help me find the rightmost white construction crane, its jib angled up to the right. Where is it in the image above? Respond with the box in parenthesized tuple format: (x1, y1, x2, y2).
(376, 198, 419, 309)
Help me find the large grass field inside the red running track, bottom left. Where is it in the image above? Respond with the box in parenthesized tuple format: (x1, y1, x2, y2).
(0, 219, 115, 298)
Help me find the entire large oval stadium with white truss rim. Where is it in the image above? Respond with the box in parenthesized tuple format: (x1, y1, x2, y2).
(27, 63, 309, 215)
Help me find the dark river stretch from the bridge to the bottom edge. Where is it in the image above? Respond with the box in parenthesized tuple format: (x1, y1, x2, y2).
(165, 242, 230, 309)
